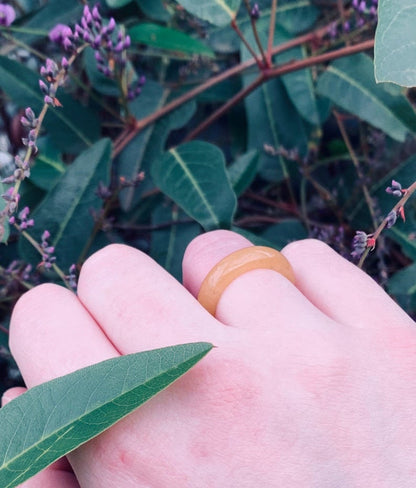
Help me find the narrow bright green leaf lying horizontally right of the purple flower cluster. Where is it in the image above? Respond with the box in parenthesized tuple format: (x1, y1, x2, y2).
(128, 23, 215, 58)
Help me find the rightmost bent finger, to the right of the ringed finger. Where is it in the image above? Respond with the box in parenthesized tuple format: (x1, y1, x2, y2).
(282, 239, 414, 328)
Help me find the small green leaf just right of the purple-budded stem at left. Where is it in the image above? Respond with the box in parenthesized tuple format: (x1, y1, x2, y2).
(30, 137, 66, 191)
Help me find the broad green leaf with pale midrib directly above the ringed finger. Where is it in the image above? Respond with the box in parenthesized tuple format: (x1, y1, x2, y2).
(151, 141, 236, 230)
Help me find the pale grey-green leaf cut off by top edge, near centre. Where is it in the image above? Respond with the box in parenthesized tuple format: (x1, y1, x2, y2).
(177, 0, 241, 25)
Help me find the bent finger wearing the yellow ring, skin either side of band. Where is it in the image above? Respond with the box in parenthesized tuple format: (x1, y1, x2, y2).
(183, 230, 334, 327)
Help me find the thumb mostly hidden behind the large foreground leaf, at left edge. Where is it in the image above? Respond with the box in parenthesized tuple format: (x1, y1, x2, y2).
(1, 386, 79, 488)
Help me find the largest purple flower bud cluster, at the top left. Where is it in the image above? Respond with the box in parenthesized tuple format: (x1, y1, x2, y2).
(49, 5, 146, 100)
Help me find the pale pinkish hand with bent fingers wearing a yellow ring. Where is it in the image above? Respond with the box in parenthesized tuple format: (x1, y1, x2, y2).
(6, 231, 416, 488)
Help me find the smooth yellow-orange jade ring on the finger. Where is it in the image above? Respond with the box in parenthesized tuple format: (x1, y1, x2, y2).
(198, 246, 295, 316)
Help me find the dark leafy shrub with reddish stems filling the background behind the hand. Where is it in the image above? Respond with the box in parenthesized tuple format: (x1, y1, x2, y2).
(0, 0, 416, 480)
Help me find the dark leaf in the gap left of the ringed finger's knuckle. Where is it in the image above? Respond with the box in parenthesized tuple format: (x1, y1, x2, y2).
(150, 203, 201, 282)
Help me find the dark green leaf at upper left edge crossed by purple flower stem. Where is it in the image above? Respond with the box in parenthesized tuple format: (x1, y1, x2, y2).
(0, 56, 100, 152)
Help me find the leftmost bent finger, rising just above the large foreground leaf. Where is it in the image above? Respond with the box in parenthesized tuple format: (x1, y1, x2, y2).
(10, 284, 118, 387)
